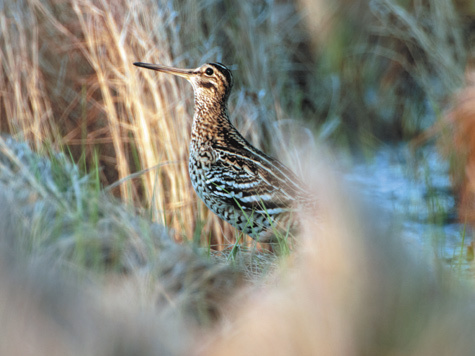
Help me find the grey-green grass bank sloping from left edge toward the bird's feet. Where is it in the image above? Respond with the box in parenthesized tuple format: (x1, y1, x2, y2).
(0, 137, 245, 325)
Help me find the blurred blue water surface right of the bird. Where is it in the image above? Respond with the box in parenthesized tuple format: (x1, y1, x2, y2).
(346, 145, 473, 274)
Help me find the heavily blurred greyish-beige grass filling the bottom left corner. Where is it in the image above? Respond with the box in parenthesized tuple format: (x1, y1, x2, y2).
(0, 245, 193, 356)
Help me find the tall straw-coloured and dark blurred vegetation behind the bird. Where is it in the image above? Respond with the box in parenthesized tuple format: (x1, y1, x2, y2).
(0, 0, 475, 249)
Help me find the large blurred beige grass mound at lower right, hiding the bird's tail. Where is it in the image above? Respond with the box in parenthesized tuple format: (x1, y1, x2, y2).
(201, 163, 475, 355)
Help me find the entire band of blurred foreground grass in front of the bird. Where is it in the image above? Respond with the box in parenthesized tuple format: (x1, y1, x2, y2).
(4, 138, 475, 356)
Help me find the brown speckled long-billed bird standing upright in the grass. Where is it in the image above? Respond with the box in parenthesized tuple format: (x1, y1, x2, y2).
(134, 62, 309, 243)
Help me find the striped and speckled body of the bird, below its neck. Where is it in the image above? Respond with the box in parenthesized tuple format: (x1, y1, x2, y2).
(189, 117, 308, 241)
